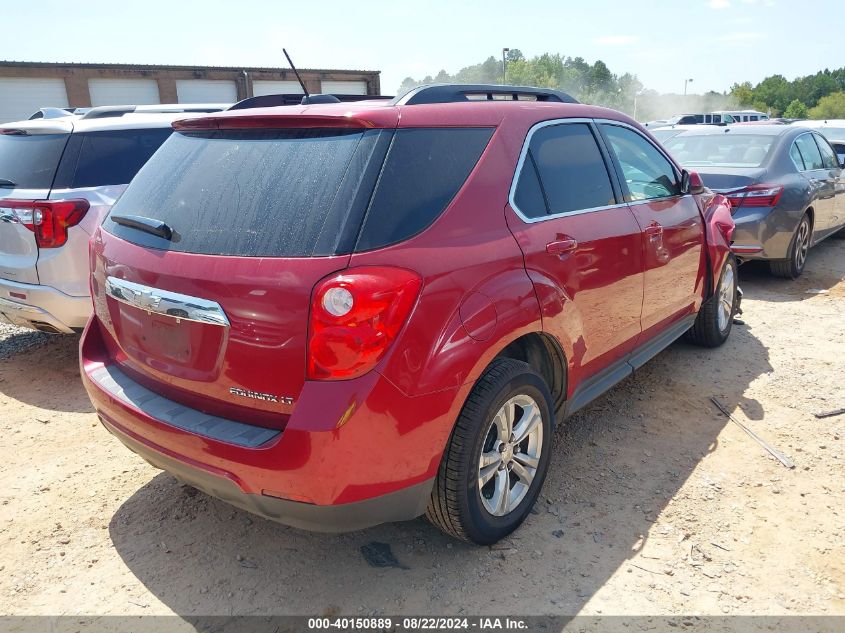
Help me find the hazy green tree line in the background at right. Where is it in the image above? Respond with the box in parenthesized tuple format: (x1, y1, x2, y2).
(399, 49, 845, 121)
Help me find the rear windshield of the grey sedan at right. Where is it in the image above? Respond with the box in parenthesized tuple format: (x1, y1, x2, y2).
(664, 132, 776, 167)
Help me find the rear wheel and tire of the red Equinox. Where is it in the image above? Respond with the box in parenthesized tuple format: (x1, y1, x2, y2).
(426, 358, 553, 545)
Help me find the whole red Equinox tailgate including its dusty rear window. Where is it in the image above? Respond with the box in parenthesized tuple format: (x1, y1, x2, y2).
(92, 123, 390, 428)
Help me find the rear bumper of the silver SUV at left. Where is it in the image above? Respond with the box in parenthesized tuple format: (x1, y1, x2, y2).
(0, 279, 91, 333)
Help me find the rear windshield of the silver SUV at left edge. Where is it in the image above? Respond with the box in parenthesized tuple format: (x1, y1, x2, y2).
(0, 133, 70, 194)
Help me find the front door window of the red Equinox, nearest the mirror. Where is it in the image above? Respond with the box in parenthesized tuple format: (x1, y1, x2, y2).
(601, 124, 681, 202)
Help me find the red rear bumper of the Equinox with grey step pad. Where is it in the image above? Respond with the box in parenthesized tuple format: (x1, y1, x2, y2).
(80, 317, 470, 532)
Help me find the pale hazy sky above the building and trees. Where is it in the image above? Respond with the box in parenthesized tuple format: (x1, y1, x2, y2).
(0, 0, 845, 94)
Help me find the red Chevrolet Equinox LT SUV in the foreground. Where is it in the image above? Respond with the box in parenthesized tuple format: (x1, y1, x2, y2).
(81, 86, 738, 544)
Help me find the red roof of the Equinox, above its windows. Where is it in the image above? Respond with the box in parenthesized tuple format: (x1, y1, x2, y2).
(174, 100, 641, 129)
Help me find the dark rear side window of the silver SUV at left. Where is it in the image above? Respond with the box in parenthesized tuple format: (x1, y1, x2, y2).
(71, 127, 173, 188)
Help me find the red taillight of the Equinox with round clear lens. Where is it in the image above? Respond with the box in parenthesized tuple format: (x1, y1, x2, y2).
(308, 267, 422, 380)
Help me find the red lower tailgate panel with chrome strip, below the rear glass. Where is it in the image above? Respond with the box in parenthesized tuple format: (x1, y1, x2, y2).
(93, 231, 349, 428)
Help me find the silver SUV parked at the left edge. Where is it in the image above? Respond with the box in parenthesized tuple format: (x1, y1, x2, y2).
(0, 104, 227, 333)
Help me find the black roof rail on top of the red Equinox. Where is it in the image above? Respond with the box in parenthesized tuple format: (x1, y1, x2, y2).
(391, 84, 578, 105)
